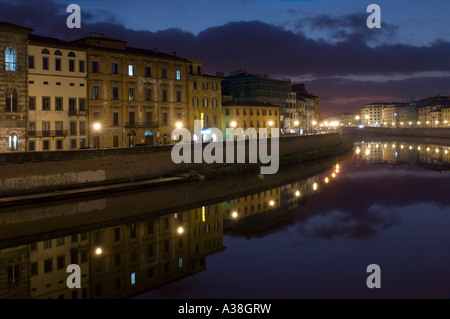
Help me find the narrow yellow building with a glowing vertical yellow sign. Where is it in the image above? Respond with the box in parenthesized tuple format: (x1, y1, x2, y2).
(187, 60, 222, 142)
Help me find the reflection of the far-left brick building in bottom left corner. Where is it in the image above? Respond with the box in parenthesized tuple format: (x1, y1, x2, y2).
(0, 246, 30, 299)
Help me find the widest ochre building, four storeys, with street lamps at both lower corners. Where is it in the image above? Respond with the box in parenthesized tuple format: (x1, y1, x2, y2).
(76, 34, 187, 148)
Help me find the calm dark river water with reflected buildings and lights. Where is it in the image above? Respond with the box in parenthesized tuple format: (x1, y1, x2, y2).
(0, 140, 450, 299)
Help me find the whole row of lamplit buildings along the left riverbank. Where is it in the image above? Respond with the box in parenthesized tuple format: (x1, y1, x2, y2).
(0, 23, 319, 152)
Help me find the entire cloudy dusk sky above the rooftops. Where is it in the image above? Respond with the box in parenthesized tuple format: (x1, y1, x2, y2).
(0, 0, 450, 116)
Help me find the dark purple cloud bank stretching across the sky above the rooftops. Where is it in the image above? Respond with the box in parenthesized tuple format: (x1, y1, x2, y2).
(0, 0, 450, 112)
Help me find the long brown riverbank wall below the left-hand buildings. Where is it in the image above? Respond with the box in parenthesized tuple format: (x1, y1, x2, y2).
(0, 133, 342, 197)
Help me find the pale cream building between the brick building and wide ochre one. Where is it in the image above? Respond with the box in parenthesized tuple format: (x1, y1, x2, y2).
(26, 35, 89, 151)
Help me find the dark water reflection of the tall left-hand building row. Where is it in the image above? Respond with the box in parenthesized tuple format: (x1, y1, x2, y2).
(0, 204, 223, 299)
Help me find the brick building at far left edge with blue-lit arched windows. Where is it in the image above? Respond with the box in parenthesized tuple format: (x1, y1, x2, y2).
(0, 22, 33, 152)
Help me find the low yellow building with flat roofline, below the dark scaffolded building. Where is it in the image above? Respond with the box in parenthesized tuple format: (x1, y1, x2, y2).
(222, 101, 280, 138)
